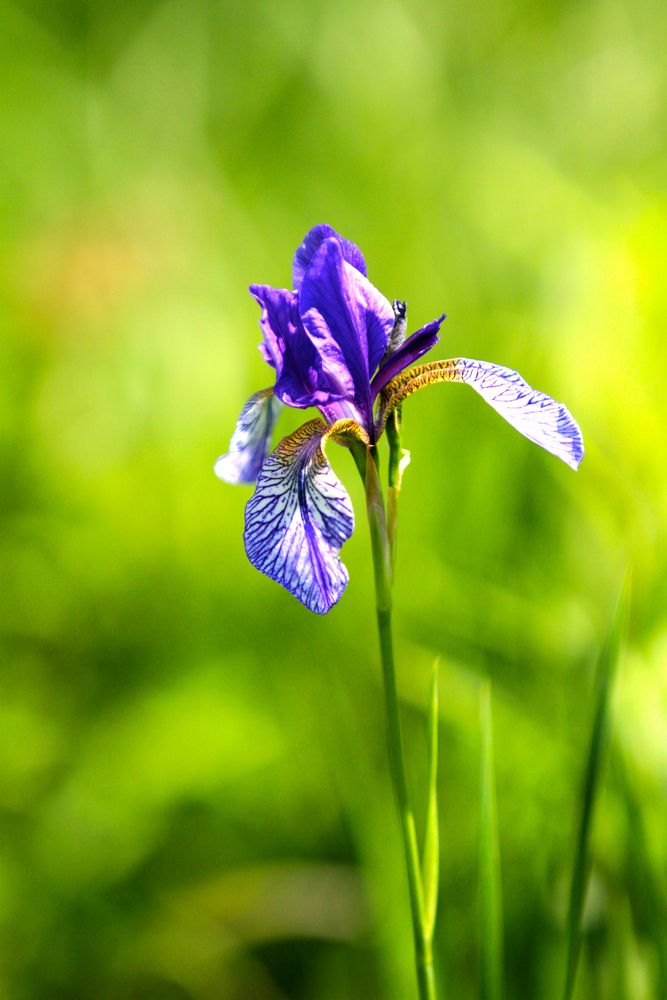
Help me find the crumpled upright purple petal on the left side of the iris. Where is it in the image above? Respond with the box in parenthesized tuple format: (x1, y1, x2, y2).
(250, 285, 354, 408)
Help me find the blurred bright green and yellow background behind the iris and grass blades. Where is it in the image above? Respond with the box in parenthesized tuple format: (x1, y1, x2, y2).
(0, 0, 667, 1000)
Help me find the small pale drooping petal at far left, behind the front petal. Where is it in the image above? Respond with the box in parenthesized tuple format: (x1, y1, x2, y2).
(214, 389, 282, 484)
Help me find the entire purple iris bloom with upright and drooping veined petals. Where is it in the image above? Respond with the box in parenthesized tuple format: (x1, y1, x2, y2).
(215, 225, 584, 614)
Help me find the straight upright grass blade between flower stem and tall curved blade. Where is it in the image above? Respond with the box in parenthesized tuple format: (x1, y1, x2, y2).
(479, 681, 503, 1000)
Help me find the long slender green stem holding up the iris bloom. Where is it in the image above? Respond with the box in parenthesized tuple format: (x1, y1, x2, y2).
(366, 449, 437, 1000)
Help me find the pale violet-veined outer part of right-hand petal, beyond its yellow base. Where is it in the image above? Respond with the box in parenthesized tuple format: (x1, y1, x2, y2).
(456, 358, 584, 469)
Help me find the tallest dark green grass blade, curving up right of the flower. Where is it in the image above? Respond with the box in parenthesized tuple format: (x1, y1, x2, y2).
(563, 574, 630, 1000)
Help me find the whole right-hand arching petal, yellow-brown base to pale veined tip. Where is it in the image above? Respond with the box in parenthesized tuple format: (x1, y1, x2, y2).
(376, 358, 584, 469)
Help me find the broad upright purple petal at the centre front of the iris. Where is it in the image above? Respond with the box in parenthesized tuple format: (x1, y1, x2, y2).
(299, 239, 394, 426)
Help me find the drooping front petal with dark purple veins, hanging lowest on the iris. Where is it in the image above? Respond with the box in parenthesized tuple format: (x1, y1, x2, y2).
(244, 419, 368, 615)
